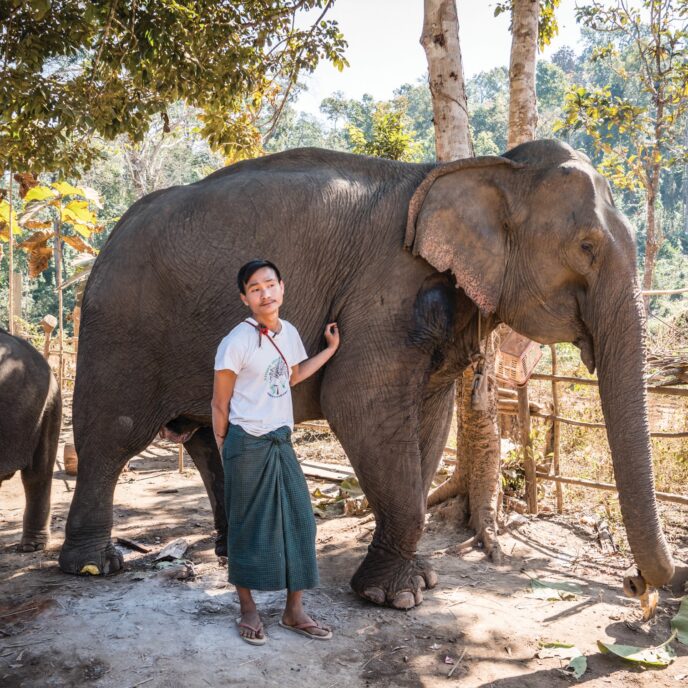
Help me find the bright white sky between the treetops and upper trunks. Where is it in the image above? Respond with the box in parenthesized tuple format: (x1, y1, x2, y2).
(296, 0, 580, 115)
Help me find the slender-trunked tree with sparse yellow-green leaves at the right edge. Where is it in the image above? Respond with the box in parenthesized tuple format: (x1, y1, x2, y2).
(563, 0, 688, 310)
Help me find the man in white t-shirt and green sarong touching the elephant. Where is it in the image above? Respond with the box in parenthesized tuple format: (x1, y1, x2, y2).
(212, 260, 339, 645)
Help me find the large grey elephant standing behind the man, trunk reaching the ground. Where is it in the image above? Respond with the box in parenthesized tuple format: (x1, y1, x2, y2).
(59, 140, 673, 609)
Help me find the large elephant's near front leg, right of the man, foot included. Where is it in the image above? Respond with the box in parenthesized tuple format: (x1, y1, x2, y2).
(322, 356, 437, 609)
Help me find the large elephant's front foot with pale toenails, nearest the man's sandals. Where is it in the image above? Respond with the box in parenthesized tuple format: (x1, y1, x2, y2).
(351, 545, 437, 609)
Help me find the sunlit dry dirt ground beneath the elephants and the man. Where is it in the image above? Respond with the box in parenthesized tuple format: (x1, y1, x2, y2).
(0, 396, 688, 688)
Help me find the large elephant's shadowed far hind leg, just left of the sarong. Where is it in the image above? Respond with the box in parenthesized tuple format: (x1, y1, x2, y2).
(184, 427, 227, 557)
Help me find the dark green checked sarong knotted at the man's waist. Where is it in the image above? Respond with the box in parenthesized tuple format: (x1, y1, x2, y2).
(222, 425, 318, 590)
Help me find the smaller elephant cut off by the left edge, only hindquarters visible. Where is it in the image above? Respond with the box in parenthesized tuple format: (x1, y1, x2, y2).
(0, 328, 62, 552)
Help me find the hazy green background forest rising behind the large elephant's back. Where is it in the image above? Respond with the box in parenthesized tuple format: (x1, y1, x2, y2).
(0, 0, 688, 330)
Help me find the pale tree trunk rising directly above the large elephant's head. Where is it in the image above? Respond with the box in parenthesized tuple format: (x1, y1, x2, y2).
(508, 0, 540, 148)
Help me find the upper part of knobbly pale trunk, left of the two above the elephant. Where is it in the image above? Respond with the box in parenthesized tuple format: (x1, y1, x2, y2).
(420, 0, 473, 162)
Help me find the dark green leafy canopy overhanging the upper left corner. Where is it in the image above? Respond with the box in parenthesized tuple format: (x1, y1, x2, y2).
(0, 0, 346, 175)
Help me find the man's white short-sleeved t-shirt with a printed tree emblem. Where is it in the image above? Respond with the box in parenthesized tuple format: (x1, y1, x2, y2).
(215, 318, 308, 437)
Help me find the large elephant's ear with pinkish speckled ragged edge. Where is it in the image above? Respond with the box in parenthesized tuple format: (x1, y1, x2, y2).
(404, 156, 522, 314)
